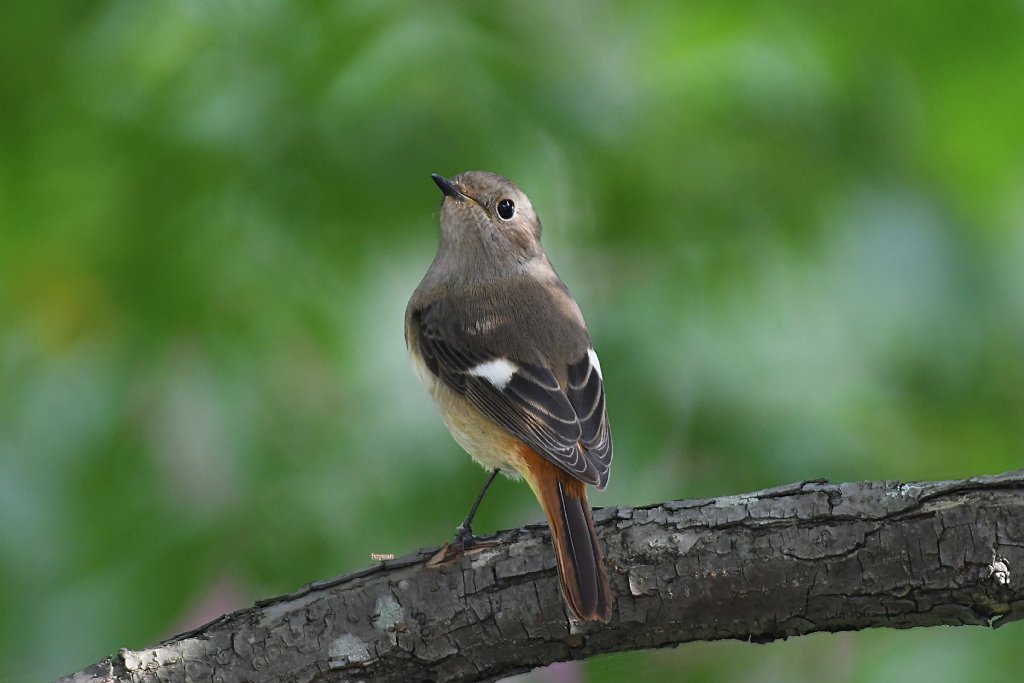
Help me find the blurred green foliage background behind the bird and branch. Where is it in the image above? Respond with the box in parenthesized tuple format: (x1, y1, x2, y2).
(0, 0, 1024, 683)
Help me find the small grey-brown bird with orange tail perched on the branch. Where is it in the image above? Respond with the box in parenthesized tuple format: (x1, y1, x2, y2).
(406, 171, 611, 622)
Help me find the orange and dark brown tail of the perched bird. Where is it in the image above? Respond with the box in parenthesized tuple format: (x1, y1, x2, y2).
(523, 447, 611, 622)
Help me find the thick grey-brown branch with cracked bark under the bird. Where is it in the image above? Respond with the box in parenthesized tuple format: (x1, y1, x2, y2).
(62, 470, 1024, 683)
